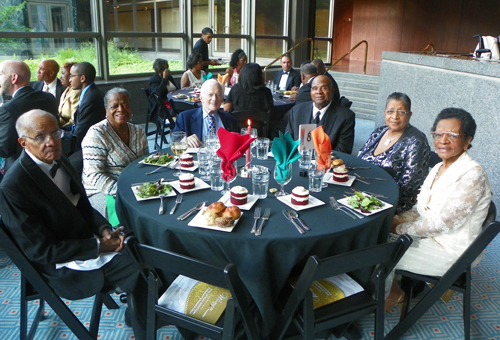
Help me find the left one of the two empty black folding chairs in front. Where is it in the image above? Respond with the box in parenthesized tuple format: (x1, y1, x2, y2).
(125, 236, 261, 340)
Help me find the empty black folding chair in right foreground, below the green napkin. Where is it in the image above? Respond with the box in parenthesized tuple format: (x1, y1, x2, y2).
(269, 235, 412, 340)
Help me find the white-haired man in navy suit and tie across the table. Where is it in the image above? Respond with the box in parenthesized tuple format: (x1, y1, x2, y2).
(174, 79, 239, 148)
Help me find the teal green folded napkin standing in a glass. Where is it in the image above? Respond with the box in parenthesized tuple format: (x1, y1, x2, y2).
(271, 131, 300, 183)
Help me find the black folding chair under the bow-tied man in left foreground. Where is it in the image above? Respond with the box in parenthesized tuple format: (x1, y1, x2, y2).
(0, 217, 119, 340)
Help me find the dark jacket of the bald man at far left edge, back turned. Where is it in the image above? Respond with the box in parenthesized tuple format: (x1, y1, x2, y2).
(0, 86, 59, 171)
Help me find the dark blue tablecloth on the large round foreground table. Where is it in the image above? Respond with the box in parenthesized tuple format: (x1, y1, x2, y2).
(116, 149, 399, 335)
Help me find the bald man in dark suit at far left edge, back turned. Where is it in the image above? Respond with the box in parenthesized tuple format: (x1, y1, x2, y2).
(0, 60, 58, 173)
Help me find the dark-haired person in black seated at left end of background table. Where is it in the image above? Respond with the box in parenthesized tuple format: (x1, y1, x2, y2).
(148, 58, 178, 123)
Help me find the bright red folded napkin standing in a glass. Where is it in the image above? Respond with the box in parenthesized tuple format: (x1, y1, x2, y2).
(217, 127, 255, 182)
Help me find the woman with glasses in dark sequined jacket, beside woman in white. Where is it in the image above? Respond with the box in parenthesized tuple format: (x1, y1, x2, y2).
(358, 92, 430, 214)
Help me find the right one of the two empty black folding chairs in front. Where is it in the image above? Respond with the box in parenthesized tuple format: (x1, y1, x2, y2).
(270, 235, 412, 339)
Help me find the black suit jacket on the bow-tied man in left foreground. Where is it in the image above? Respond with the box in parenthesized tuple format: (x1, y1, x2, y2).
(0, 151, 109, 299)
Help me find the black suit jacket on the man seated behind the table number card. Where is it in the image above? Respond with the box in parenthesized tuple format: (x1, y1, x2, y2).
(286, 102, 355, 154)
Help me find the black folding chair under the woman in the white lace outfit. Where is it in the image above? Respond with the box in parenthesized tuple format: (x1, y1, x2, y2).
(386, 202, 500, 340)
